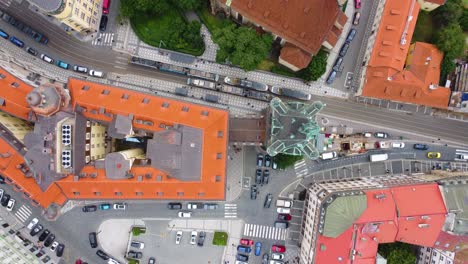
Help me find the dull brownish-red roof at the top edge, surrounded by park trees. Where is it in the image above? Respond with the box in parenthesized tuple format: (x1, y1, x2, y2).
(224, 0, 343, 55)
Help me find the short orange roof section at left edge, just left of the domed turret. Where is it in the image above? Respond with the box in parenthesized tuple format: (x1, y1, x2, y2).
(0, 67, 33, 120)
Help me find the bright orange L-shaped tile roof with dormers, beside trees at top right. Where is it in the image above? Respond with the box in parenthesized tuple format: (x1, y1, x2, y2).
(362, 0, 450, 108)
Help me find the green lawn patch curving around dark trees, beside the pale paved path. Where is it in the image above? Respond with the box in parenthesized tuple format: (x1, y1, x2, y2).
(131, 8, 205, 56)
